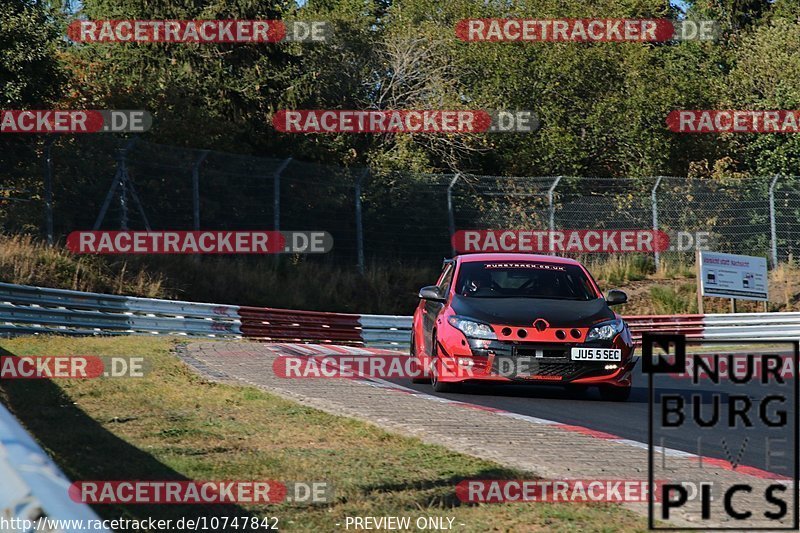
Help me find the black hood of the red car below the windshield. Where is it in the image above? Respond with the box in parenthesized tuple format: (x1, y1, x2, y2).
(450, 295, 614, 328)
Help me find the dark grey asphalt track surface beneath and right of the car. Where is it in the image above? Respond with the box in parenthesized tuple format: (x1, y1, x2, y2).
(391, 351, 798, 478)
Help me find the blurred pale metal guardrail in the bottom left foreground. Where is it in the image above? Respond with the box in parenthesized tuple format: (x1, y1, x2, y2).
(0, 404, 110, 533)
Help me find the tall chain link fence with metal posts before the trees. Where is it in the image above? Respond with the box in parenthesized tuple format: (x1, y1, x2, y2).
(0, 135, 800, 269)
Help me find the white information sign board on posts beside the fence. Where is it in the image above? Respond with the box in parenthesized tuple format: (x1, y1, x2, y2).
(700, 251, 769, 301)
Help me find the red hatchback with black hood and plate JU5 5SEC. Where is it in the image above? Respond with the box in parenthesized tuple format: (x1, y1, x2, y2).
(411, 254, 636, 401)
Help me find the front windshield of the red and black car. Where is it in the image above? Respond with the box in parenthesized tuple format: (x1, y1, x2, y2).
(456, 261, 597, 301)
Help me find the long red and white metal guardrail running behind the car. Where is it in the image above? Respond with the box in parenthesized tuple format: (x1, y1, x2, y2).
(0, 283, 800, 349)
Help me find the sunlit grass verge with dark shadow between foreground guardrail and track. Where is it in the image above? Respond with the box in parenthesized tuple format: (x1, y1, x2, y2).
(0, 337, 645, 532)
